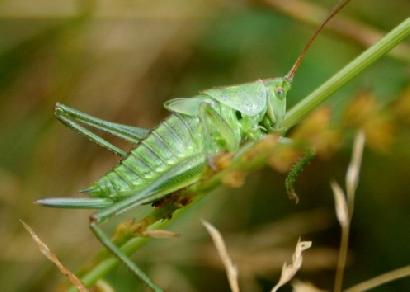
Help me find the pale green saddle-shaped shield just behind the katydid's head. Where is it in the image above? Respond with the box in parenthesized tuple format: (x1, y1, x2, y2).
(202, 80, 267, 116)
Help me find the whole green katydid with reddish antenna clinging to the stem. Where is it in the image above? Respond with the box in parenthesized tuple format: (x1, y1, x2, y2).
(37, 0, 349, 291)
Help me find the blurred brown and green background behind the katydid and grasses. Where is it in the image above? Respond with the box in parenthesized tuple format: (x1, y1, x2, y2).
(0, 0, 410, 291)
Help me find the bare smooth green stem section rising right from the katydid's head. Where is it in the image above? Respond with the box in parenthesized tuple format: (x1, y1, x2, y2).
(281, 17, 410, 130)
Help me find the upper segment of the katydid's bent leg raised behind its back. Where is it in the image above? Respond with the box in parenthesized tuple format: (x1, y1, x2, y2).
(55, 103, 149, 144)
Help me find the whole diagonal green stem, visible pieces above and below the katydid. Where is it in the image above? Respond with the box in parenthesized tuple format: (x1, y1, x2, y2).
(72, 18, 410, 287)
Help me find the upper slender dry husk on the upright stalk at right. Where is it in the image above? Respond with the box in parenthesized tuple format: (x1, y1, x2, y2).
(346, 131, 366, 220)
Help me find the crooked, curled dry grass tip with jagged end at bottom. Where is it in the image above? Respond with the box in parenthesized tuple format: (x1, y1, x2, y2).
(271, 238, 312, 292)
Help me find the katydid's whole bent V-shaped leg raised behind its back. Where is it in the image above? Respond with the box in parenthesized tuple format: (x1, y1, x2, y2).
(55, 103, 149, 157)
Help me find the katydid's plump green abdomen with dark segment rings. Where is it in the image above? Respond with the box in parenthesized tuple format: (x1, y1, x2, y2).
(87, 114, 203, 199)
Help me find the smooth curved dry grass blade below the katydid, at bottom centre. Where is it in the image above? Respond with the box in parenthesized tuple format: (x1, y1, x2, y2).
(202, 220, 240, 292)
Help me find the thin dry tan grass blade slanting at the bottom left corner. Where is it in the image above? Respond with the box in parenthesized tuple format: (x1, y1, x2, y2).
(20, 220, 88, 292)
